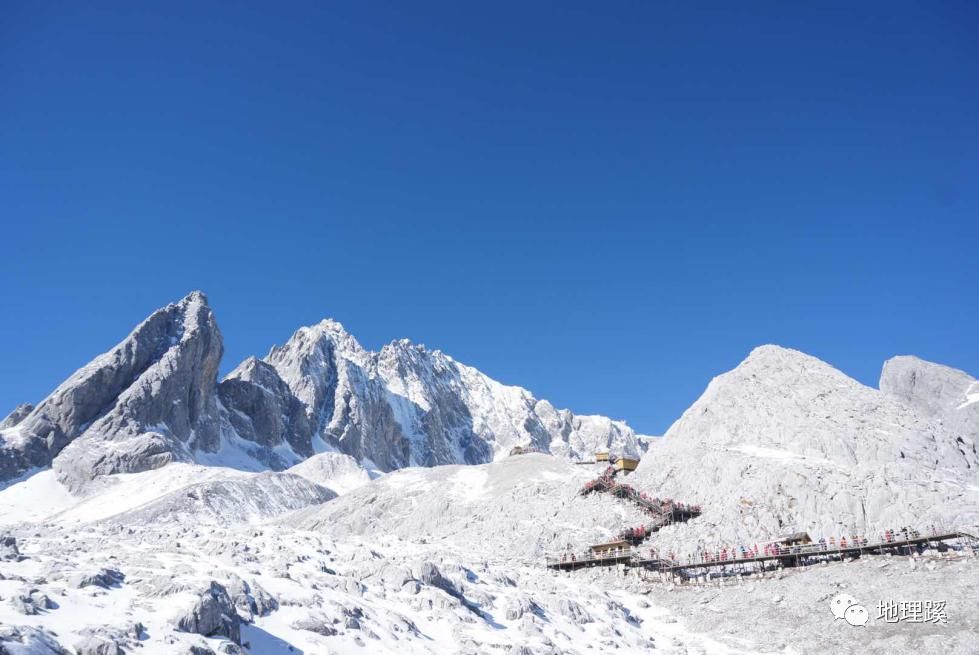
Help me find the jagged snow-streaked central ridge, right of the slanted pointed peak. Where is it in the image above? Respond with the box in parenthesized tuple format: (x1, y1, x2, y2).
(256, 321, 638, 470)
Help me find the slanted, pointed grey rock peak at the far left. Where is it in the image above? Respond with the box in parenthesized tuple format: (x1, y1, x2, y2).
(0, 292, 222, 488)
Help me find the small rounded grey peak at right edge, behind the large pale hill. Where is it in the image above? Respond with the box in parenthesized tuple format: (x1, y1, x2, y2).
(880, 356, 979, 440)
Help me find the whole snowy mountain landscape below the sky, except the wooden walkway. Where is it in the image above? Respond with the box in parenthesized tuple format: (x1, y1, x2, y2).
(0, 308, 979, 655)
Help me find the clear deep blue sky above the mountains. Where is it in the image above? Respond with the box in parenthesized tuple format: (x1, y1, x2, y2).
(0, 2, 979, 433)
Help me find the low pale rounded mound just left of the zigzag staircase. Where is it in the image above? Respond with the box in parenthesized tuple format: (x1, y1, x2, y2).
(279, 454, 648, 562)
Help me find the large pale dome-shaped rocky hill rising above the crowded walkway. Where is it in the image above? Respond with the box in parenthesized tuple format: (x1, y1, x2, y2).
(630, 346, 979, 549)
